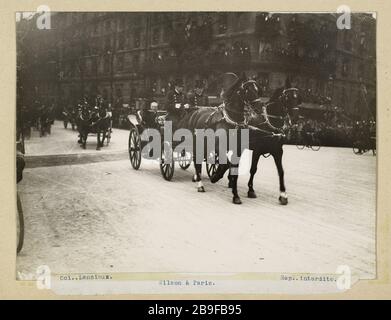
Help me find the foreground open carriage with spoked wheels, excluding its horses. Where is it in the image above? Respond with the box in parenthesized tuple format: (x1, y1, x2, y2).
(128, 107, 217, 181)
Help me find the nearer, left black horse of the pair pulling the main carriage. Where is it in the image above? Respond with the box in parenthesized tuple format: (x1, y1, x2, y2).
(178, 73, 260, 204)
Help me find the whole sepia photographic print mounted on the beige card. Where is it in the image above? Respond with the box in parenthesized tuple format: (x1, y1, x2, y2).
(16, 7, 377, 294)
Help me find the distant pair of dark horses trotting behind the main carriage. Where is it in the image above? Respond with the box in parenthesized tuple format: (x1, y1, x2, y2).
(77, 103, 111, 150)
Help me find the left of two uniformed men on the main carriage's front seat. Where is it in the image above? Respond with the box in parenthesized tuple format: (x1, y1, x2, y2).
(166, 79, 189, 126)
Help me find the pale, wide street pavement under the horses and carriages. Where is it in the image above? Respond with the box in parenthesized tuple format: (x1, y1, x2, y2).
(17, 122, 376, 279)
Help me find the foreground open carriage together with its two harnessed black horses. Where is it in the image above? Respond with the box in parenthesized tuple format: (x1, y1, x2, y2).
(128, 73, 299, 205)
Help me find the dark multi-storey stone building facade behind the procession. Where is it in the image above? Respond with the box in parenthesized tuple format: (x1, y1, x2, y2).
(17, 12, 376, 116)
